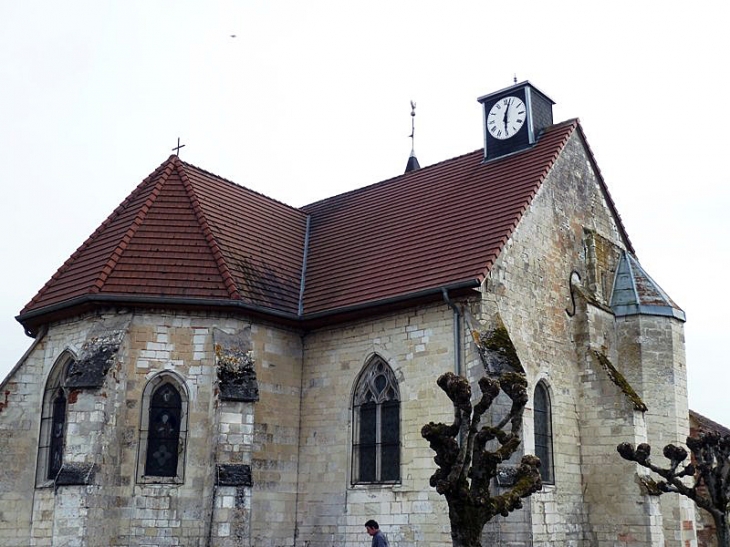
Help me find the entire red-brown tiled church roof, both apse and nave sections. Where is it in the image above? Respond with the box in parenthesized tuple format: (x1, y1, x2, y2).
(18, 120, 631, 332)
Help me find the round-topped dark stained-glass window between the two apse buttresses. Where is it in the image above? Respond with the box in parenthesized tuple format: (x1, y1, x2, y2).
(137, 372, 188, 482)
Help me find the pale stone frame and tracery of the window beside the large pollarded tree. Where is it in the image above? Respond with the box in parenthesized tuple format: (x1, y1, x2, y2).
(350, 354, 402, 486)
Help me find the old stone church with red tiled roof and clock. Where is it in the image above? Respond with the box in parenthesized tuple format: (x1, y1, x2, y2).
(0, 82, 697, 547)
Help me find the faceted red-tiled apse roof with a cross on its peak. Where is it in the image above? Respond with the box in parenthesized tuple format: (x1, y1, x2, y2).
(20, 156, 306, 324)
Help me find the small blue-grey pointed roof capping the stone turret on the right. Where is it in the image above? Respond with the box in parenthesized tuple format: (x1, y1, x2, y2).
(611, 252, 686, 321)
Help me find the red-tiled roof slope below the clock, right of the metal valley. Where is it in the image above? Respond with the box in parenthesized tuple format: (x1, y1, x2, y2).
(304, 121, 578, 314)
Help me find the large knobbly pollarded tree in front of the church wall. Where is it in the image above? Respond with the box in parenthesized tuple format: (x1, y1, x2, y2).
(421, 318, 542, 547)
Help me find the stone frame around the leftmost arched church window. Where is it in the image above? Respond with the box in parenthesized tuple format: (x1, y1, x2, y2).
(36, 349, 76, 488)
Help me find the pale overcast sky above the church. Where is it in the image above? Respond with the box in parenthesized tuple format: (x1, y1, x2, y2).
(0, 0, 730, 426)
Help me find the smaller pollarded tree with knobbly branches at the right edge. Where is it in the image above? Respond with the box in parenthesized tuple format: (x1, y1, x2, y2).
(617, 432, 730, 547)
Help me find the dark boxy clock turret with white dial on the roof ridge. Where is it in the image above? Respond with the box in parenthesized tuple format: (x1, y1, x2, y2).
(477, 81, 555, 161)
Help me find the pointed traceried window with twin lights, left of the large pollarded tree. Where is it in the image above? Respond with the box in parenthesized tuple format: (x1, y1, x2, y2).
(352, 357, 400, 483)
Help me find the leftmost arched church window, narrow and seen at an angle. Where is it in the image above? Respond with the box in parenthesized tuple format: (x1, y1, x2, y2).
(36, 353, 73, 485)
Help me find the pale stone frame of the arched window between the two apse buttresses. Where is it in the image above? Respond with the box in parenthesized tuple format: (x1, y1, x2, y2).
(137, 370, 190, 484)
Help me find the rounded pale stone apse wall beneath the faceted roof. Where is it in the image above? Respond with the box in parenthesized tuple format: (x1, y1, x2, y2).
(0, 312, 301, 547)
